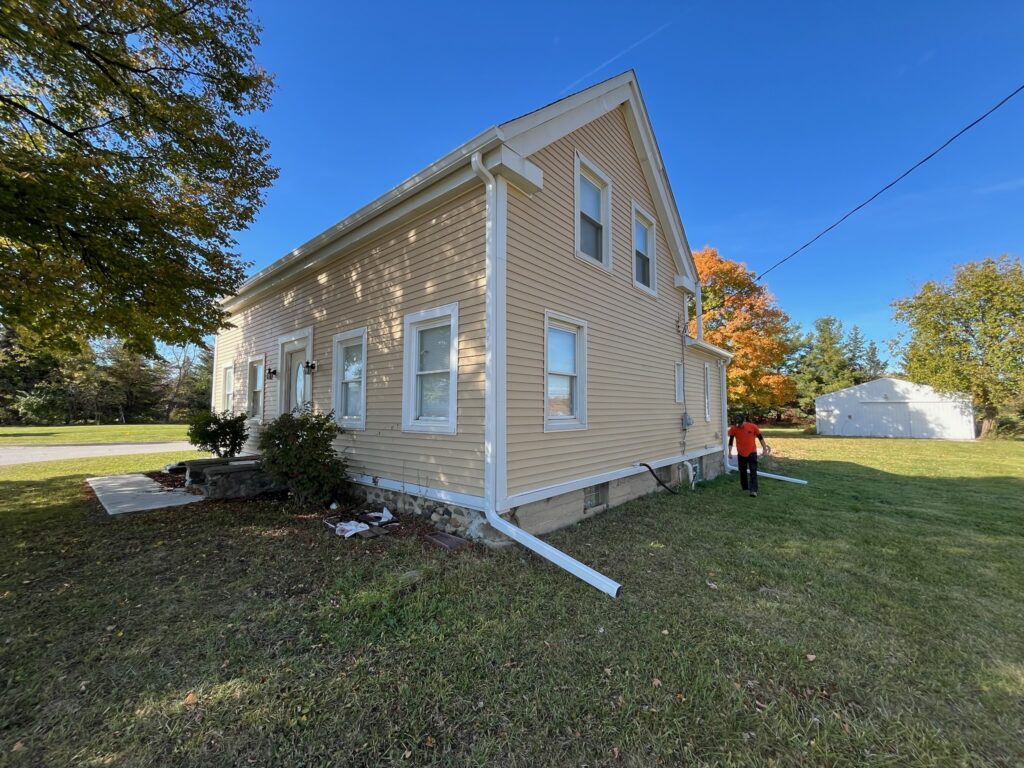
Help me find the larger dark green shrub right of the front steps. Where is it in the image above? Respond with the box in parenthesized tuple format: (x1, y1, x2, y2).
(259, 406, 347, 508)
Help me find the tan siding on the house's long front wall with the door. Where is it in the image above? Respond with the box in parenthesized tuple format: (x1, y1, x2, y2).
(214, 189, 485, 496)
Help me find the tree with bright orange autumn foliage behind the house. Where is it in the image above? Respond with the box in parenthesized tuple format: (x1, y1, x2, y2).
(690, 246, 797, 414)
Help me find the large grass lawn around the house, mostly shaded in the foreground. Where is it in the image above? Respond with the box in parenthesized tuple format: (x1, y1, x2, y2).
(0, 432, 1024, 766)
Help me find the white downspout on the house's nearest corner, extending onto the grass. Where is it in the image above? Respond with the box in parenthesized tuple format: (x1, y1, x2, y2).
(471, 152, 622, 597)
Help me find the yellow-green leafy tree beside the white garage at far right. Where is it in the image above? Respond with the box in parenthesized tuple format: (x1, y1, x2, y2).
(893, 255, 1024, 437)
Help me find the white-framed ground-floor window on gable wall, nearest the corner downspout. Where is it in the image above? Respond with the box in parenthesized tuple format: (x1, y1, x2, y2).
(544, 312, 587, 431)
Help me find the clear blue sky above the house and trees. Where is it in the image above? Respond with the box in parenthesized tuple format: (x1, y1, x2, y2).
(239, 0, 1024, 354)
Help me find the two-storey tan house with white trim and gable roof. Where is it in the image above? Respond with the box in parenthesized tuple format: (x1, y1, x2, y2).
(213, 72, 730, 591)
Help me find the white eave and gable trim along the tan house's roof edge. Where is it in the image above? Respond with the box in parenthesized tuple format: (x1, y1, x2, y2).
(223, 70, 697, 309)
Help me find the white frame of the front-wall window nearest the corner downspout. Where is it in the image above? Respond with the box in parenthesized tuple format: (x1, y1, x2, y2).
(401, 302, 459, 434)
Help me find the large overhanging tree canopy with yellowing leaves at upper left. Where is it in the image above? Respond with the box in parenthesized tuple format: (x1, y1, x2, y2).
(0, 0, 276, 354)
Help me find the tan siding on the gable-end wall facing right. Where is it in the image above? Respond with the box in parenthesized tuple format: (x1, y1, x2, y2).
(507, 110, 721, 494)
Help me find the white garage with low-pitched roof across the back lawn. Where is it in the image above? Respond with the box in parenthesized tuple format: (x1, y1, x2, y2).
(814, 379, 974, 440)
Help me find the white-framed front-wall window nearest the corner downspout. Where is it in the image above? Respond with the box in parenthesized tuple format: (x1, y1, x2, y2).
(402, 304, 459, 434)
